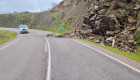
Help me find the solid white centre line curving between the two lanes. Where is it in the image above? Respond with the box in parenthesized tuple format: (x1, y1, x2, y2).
(44, 37, 51, 80)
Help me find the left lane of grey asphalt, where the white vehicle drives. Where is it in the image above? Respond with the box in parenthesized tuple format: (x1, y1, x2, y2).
(0, 29, 47, 80)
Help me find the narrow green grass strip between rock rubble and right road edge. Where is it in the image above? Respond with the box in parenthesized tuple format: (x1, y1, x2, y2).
(80, 39, 140, 62)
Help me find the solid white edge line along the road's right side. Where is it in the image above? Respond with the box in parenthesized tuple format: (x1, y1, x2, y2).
(71, 39, 140, 73)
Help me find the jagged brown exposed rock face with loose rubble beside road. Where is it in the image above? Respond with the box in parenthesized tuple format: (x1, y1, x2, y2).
(75, 0, 140, 52)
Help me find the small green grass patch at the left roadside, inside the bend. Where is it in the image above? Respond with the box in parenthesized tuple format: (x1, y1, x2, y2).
(0, 30, 16, 44)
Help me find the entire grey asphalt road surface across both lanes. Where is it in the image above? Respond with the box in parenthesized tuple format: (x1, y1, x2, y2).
(0, 29, 140, 80)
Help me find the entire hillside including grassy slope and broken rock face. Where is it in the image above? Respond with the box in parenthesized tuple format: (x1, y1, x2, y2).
(0, 0, 140, 52)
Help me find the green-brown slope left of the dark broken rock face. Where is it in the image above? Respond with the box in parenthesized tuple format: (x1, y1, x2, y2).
(0, 0, 89, 30)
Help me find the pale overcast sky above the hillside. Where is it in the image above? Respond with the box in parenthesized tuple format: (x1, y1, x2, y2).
(0, 0, 62, 14)
